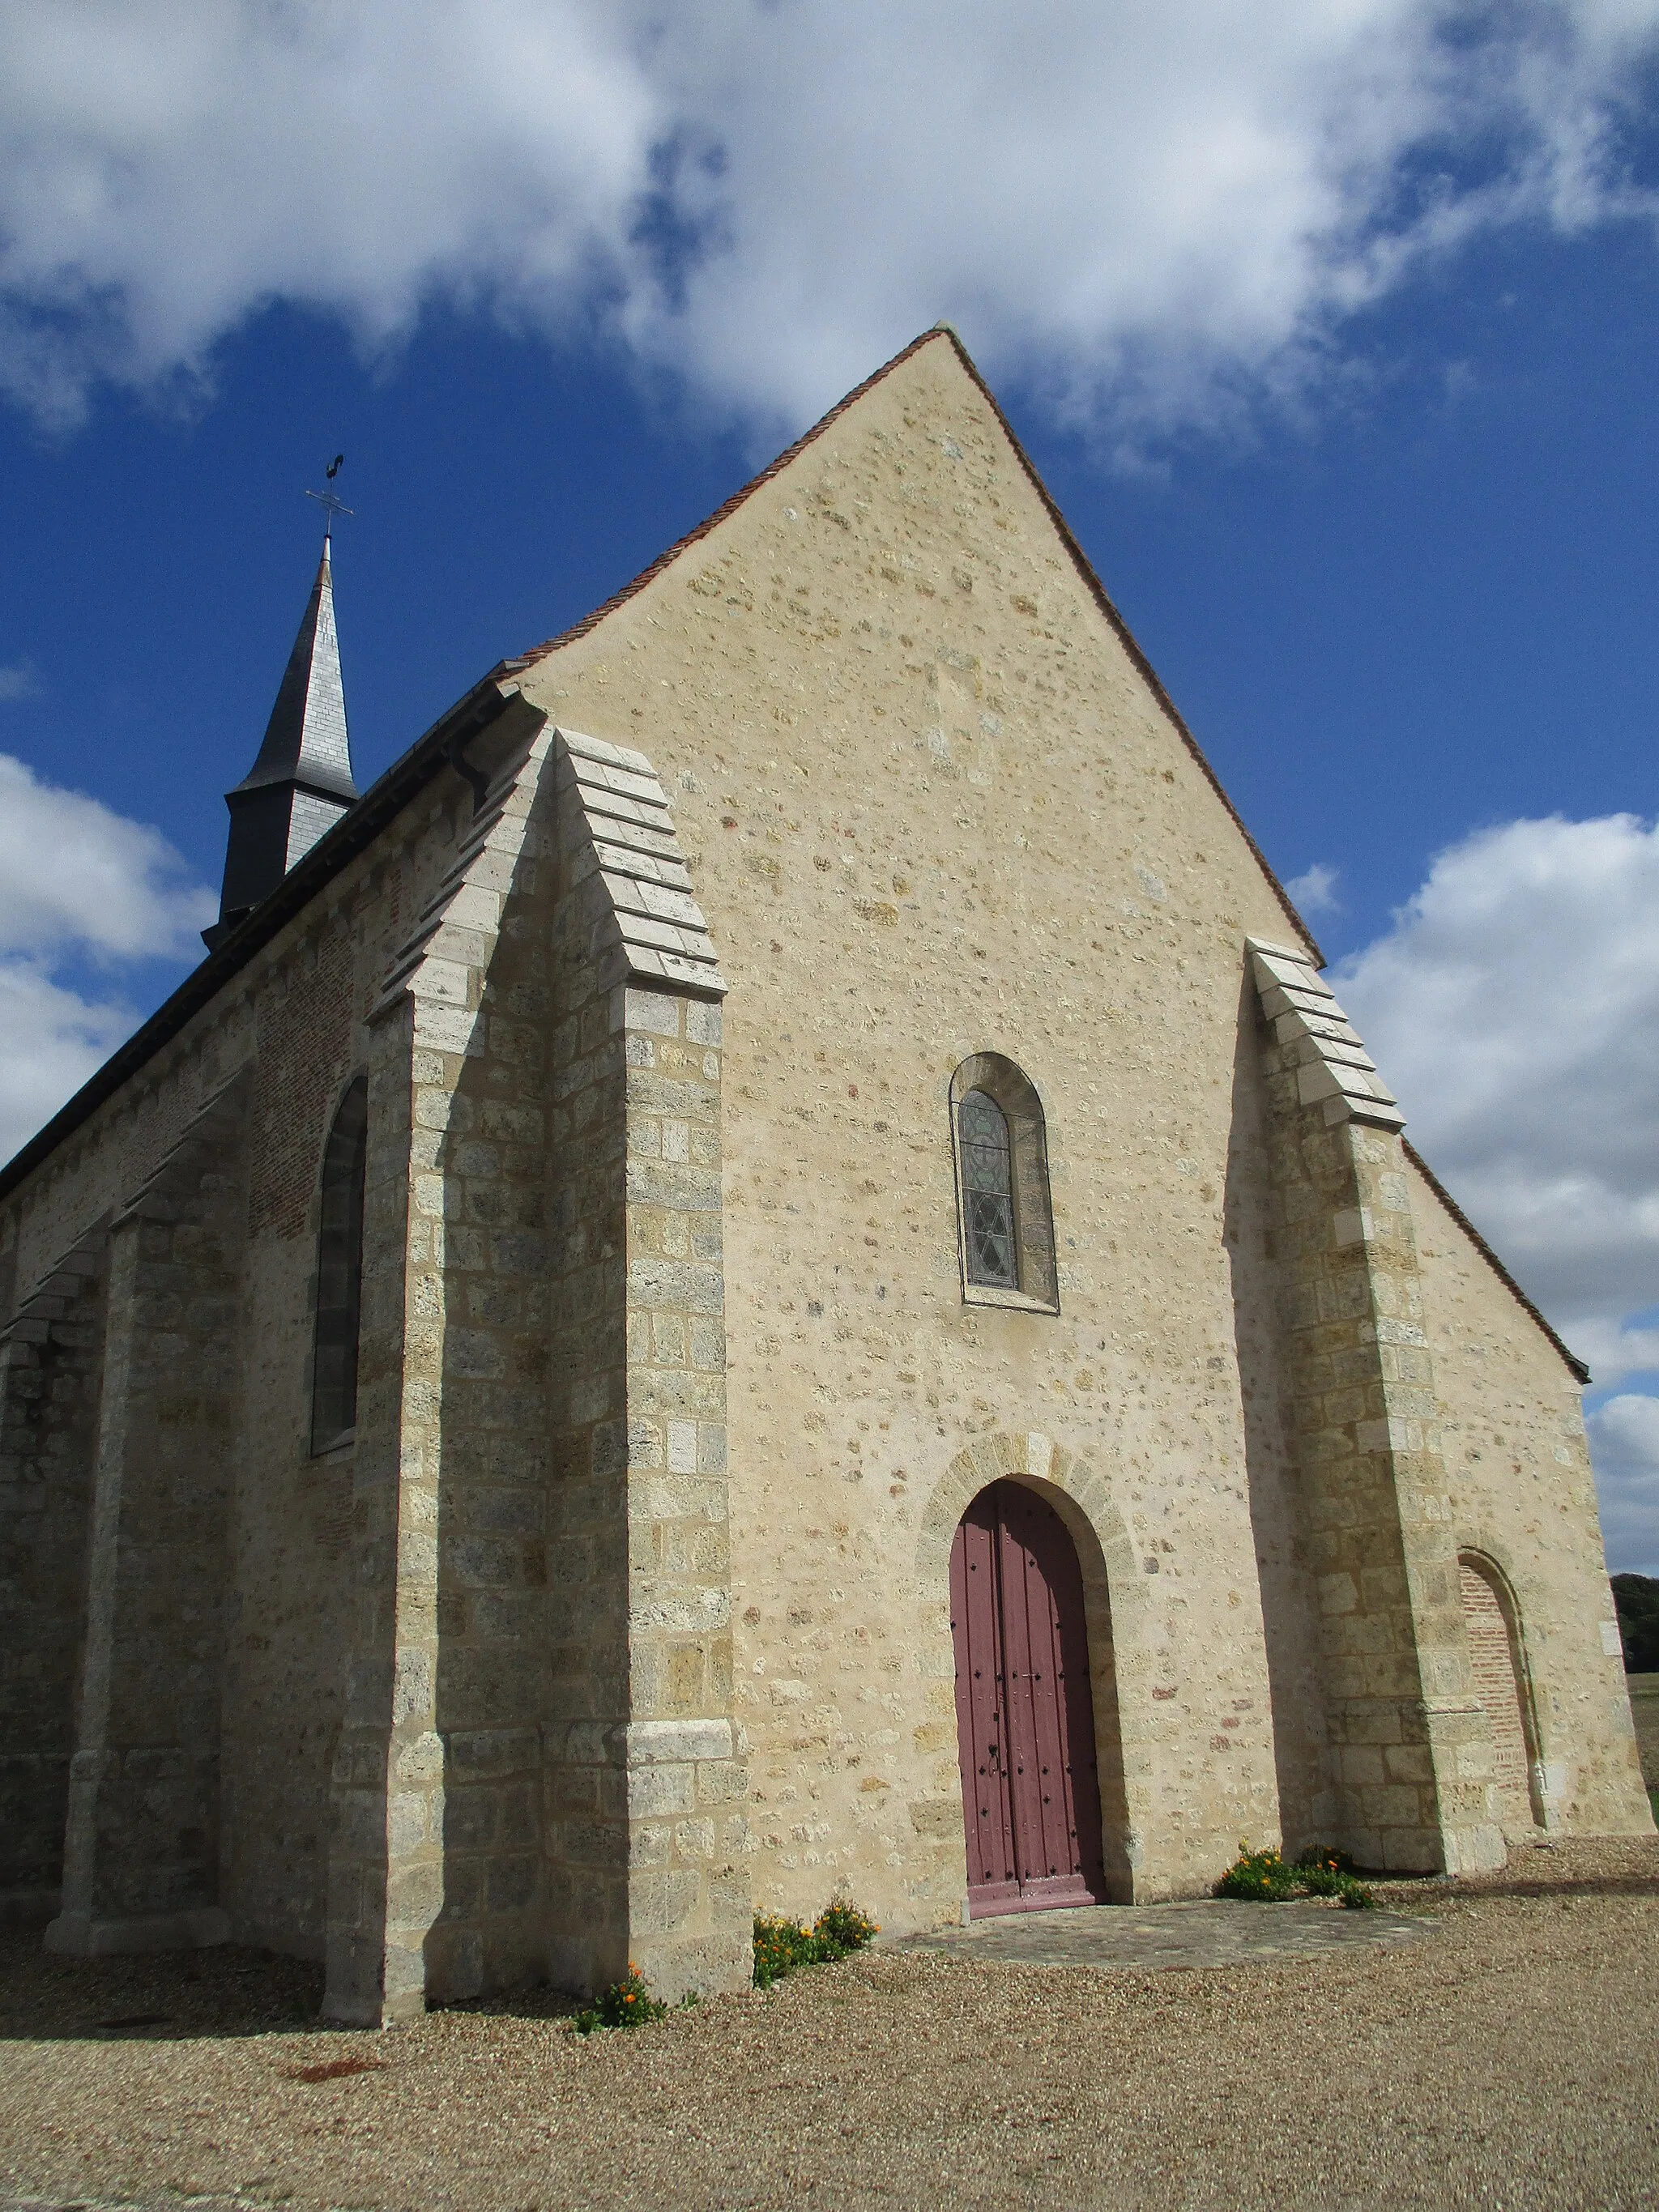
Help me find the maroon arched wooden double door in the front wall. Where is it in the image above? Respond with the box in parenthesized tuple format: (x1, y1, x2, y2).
(951, 1482, 1106, 1920)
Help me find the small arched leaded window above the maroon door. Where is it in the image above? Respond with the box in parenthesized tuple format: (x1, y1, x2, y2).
(951, 1053, 1060, 1314)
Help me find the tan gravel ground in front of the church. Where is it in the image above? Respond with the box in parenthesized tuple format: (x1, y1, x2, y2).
(0, 1838, 1659, 2212)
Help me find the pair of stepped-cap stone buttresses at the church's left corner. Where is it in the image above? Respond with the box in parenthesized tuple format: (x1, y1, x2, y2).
(325, 710, 750, 2024)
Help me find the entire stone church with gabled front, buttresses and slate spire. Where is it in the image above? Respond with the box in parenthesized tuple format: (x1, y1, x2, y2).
(0, 332, 1650, 2022)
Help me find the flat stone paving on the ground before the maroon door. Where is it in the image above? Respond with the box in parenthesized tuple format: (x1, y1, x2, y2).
(900, 1898, 1435, 1973)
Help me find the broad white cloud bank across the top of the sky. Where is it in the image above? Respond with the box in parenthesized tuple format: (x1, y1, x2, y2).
(0, 0, 1659, 440)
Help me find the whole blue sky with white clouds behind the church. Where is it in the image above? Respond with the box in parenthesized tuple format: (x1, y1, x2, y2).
(0, 0, 1659, 1573)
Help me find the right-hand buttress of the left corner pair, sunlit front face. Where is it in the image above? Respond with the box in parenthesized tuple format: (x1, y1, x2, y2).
(546, 748, 750, 1995)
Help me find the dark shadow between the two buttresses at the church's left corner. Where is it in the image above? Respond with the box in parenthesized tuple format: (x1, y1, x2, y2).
(416, 777, 570, 2004)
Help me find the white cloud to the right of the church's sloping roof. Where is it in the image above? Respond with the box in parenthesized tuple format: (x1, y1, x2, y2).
(1334, 814, 1659, 1571)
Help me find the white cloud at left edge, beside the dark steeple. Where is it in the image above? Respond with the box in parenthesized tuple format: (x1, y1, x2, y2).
(0, 752, 217, 1161)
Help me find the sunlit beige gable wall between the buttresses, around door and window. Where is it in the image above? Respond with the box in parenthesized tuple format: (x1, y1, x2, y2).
(524, 343, 1290, 1929)
